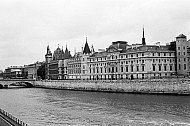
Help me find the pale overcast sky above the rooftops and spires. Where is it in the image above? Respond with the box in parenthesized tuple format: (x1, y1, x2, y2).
(0, 0, 190, 70)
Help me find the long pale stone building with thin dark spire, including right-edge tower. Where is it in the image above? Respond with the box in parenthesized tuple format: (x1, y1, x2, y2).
(88, 29, 190, 80)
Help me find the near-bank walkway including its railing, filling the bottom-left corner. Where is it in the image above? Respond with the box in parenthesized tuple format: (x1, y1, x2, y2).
(0, 108, 28, 126)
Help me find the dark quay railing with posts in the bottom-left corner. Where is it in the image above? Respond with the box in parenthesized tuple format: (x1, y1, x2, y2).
(0, 108, 28, 126)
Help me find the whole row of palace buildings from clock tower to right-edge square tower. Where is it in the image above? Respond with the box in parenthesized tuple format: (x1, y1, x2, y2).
(45, 29, 190, 80)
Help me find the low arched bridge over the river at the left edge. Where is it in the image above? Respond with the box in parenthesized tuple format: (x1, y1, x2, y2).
(0, 79, 35, 88)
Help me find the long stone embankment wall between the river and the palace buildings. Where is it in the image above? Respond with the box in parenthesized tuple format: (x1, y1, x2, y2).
(35, 78, 190, 95)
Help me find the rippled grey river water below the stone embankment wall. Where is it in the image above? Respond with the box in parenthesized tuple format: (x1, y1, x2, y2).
(0, 88, 190, 126)
